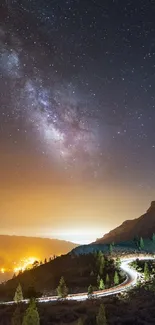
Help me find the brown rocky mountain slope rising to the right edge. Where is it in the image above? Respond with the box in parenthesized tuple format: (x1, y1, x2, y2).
(95, 201, 155, 244)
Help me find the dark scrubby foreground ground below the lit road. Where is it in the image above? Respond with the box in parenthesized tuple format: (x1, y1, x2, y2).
(0, 287, 155, 325)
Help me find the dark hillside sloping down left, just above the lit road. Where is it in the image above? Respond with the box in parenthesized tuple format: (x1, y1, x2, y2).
(0, 253, 121, 300)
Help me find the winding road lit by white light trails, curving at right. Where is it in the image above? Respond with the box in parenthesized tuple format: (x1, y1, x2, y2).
(0, 256, 155, 305)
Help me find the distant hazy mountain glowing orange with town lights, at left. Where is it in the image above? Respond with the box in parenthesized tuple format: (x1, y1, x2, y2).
(0, 235, 78, 268)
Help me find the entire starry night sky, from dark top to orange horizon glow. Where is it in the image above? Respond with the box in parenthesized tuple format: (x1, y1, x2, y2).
(0, 0, 155, 243)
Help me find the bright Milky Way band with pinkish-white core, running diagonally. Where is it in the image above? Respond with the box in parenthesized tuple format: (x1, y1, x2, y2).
(0, 24, 100, 178)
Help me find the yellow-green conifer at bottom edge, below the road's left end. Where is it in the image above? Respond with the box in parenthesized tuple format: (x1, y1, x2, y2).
(22, 299, 40, 325)
